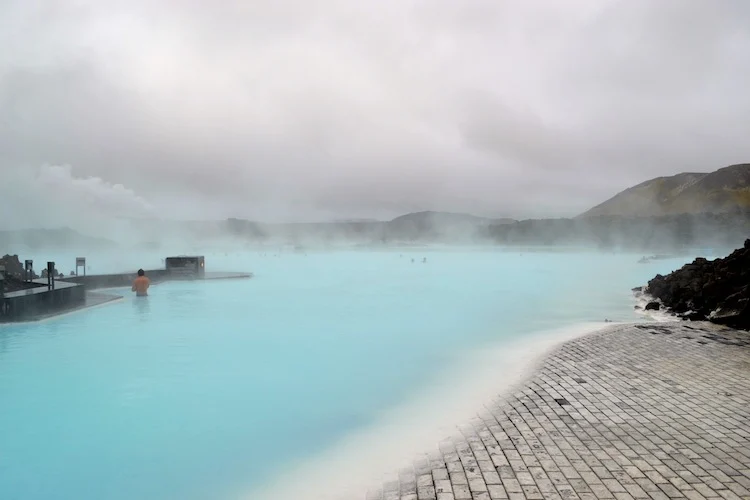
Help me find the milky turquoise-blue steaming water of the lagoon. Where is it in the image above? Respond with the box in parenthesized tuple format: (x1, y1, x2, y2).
(0, 250, 704, 500)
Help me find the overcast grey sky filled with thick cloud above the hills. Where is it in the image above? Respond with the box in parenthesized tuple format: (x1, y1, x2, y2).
(0, 0, 750, 226)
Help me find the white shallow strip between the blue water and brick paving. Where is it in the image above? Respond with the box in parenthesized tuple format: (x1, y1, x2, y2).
(241, 322, 627, 500)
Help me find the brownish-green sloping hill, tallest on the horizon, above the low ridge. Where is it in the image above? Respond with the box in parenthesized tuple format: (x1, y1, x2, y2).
(579, 163, 750, 217)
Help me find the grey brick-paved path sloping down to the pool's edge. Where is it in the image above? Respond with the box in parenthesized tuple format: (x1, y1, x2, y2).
(367, 323, 750, 500)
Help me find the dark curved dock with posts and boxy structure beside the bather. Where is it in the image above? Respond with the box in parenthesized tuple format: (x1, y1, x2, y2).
(0, 256, 253, 323)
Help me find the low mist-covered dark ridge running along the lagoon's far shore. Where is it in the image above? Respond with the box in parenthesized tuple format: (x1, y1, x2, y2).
(5, 198, 750, 252)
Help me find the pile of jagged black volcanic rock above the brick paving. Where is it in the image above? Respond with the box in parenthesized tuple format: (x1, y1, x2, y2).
(646, 239, 750, 330)
